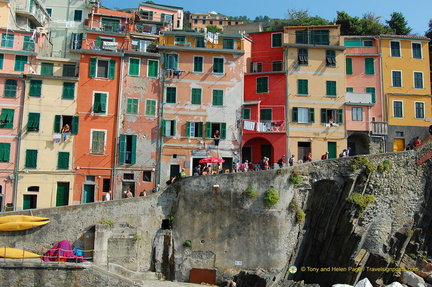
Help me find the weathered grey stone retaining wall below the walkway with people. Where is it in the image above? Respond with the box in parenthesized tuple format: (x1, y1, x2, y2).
(0, 143, 431, 286)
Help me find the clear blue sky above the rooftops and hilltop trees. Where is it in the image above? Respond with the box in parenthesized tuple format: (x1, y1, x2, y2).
(101, 0, 432, 36)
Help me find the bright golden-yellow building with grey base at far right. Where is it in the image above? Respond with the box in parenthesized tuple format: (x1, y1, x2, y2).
(379, 35, 432, 152)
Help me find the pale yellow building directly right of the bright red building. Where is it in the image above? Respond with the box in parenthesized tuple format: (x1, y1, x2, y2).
(283, 25, 347, 159)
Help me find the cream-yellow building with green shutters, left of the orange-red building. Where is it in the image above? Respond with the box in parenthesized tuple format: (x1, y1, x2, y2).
(16, 57, 78, 210)
